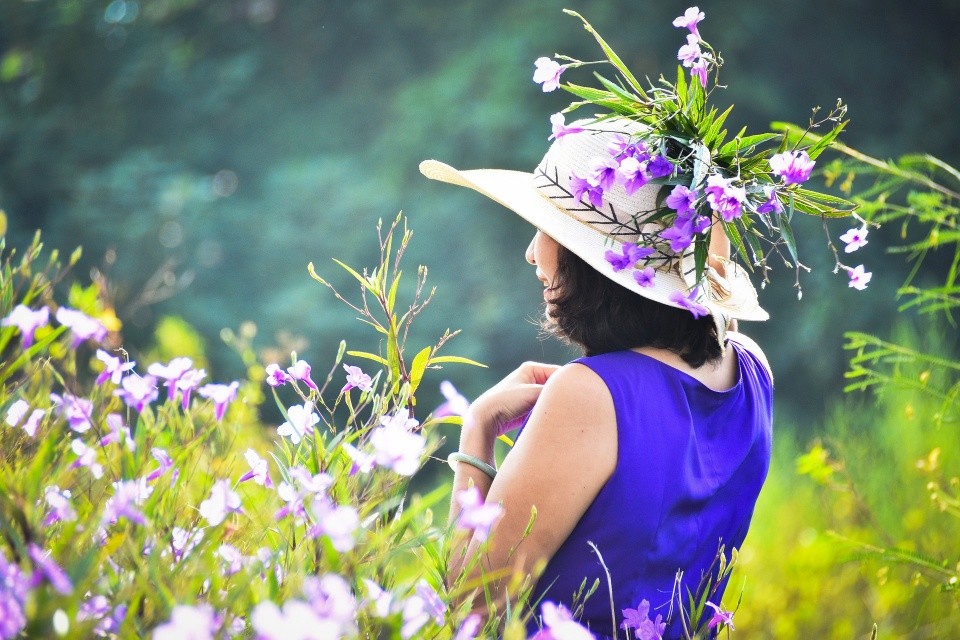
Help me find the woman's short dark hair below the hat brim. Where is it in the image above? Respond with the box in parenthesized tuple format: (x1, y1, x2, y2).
(543, 245, 723, 368)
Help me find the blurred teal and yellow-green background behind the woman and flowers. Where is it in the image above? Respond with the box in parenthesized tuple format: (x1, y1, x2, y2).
(0, 0, 960, 638)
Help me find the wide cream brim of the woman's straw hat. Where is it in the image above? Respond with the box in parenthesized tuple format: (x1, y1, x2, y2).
(420, 160, 769, 320)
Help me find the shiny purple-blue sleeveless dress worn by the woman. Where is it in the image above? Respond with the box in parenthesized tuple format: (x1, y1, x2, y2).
(529, 340, 773, 638)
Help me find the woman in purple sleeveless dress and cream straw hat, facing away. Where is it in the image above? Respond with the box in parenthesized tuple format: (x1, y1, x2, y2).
(421, 119, 772, 637)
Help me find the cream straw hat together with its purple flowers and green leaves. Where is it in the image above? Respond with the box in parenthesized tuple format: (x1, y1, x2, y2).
(420, 7, 855, 327)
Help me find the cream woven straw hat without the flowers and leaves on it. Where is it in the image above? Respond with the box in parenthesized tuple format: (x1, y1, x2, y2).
(420, 118, 769, 336)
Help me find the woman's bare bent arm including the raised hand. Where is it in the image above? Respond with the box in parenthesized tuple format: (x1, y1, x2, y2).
(448, 364, 617, 601)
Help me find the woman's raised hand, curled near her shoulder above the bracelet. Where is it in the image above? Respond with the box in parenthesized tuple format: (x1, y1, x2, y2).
(464, 362, 560, 441)
